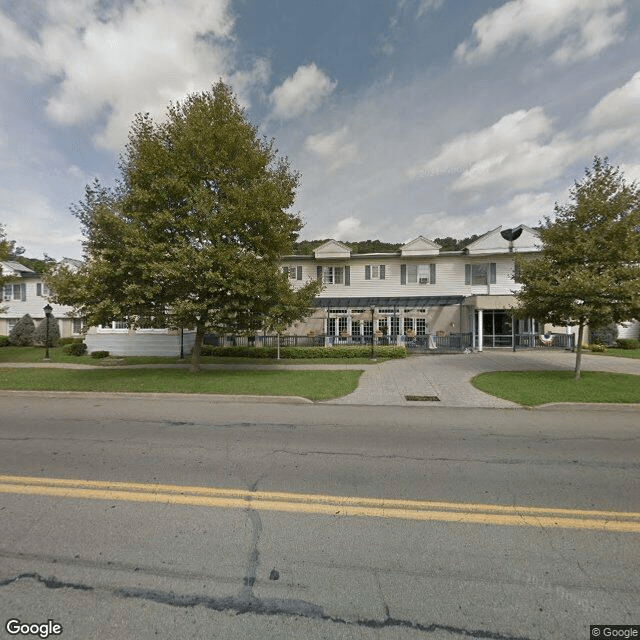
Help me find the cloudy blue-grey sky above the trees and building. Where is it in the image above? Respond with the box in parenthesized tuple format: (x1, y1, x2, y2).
(0, 0, 640, 258)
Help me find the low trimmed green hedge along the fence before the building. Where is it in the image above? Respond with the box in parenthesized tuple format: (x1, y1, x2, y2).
(196, 344, 407, 359)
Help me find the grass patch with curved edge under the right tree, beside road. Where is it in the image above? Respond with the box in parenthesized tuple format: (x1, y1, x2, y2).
(471, 371, 640, 407)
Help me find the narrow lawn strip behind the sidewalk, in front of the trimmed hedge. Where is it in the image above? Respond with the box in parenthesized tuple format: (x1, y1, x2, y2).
(0, 347, 385, 365)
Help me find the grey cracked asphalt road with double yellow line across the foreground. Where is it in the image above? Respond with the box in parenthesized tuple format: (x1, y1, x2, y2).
(0, 393, 640, 640)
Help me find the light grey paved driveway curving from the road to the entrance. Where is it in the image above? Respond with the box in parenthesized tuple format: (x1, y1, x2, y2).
(328, 349, 640, 407)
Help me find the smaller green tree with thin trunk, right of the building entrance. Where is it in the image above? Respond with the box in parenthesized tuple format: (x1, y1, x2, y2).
(516, 157, 640, 379)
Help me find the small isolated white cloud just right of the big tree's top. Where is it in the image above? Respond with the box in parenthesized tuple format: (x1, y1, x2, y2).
(271, 62, 337, 120)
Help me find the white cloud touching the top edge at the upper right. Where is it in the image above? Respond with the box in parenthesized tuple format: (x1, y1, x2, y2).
(455, 0, 626, 63)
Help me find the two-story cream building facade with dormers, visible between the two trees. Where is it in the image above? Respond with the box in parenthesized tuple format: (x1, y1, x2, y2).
(283, 225, 552, 350)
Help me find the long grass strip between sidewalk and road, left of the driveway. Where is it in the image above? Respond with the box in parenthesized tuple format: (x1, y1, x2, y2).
(0, 368, 362, 400)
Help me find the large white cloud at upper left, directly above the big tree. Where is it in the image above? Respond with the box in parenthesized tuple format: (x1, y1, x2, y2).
(0, 0, 268, 150)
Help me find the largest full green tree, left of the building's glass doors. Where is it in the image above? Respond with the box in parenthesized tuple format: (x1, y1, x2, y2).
(49, 81, 319, 370)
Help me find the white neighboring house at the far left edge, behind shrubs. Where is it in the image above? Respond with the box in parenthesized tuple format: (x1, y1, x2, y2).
(0, 258, 82, 337)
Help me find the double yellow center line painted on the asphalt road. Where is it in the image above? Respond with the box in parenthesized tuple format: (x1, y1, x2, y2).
(0, 475, 640, 533)
